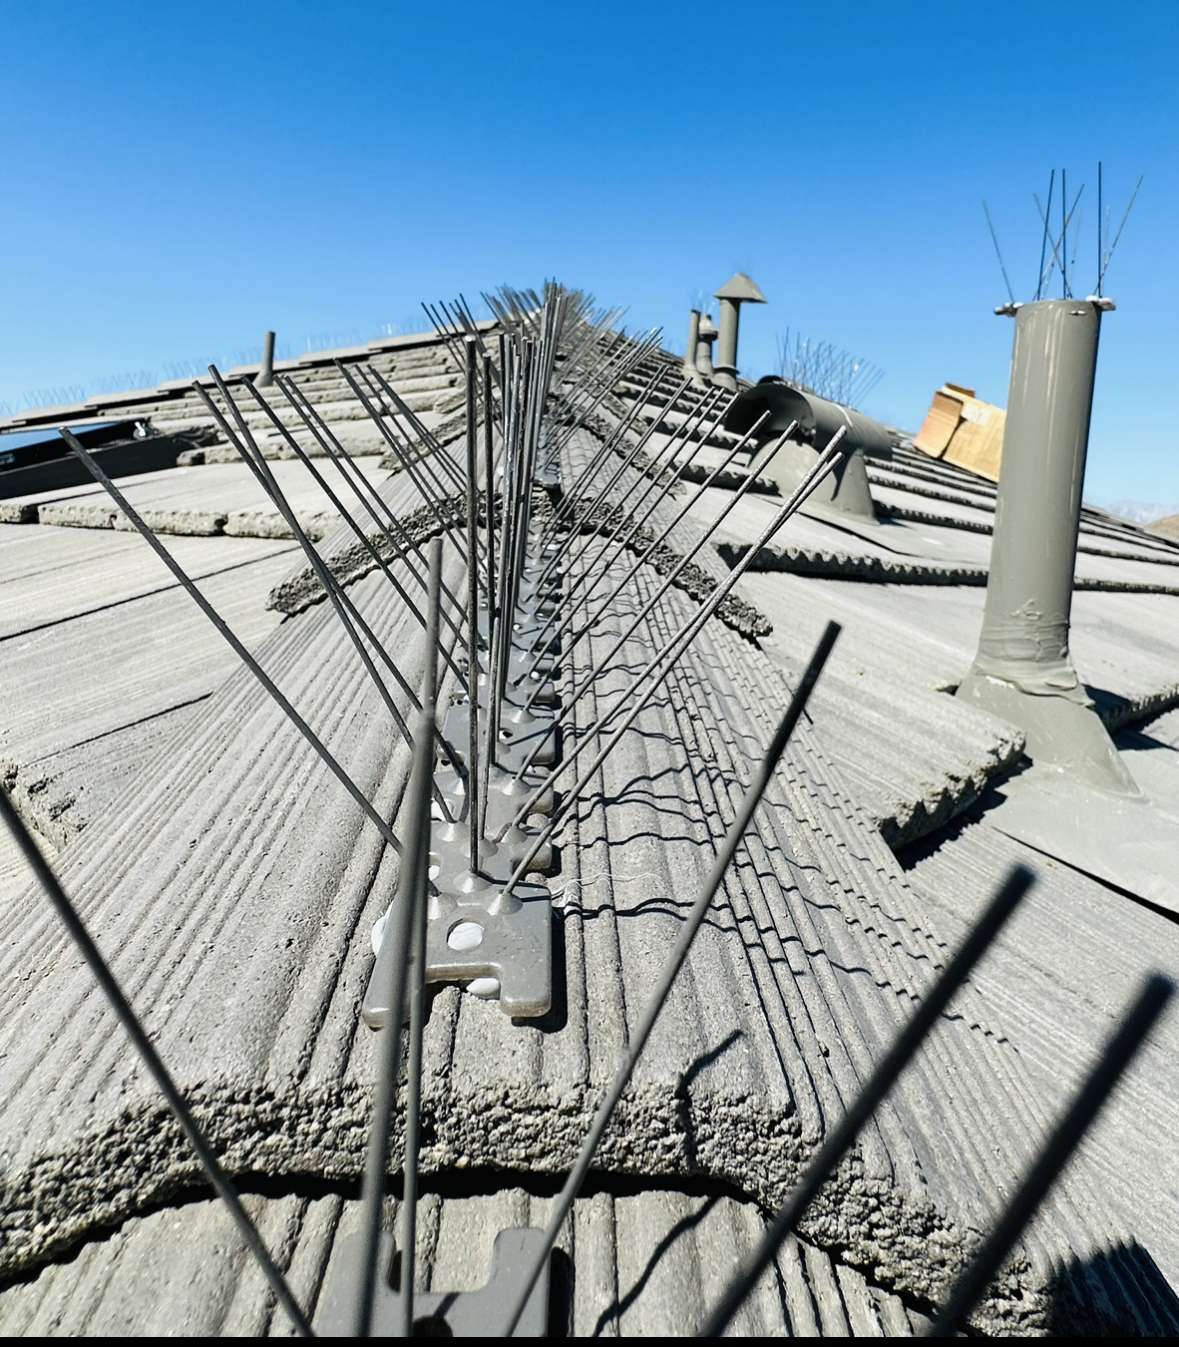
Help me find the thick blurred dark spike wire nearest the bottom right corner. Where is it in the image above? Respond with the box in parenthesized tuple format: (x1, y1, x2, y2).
(926, 974, 1175, 1338)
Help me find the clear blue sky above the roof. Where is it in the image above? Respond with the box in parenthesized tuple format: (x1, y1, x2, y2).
(0, 0, 1179, 509)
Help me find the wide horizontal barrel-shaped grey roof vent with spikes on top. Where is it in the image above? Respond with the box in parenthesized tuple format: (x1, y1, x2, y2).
(725, 376, 892, 520)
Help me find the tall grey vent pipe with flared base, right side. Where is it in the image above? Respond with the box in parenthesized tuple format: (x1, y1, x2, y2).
(958, 299, 1140, 795)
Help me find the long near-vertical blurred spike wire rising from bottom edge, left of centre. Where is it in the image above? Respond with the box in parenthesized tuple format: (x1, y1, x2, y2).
(354, 539, 442, 1338)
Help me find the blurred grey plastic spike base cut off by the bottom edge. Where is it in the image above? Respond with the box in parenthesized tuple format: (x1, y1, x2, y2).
(315, 1227, 550, 1338)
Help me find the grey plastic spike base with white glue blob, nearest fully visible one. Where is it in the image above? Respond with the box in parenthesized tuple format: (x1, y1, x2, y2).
(361, 877, 552, 1029)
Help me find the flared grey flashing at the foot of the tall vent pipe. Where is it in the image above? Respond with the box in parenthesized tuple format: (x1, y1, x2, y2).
(958, 663, 1143, 800)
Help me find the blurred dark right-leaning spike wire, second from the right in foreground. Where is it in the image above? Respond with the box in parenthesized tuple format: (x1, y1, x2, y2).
(697, 866, 1032, 1338)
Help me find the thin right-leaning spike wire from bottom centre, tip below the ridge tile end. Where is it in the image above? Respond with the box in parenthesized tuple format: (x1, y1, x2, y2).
(504, 622, 841, 1338)
